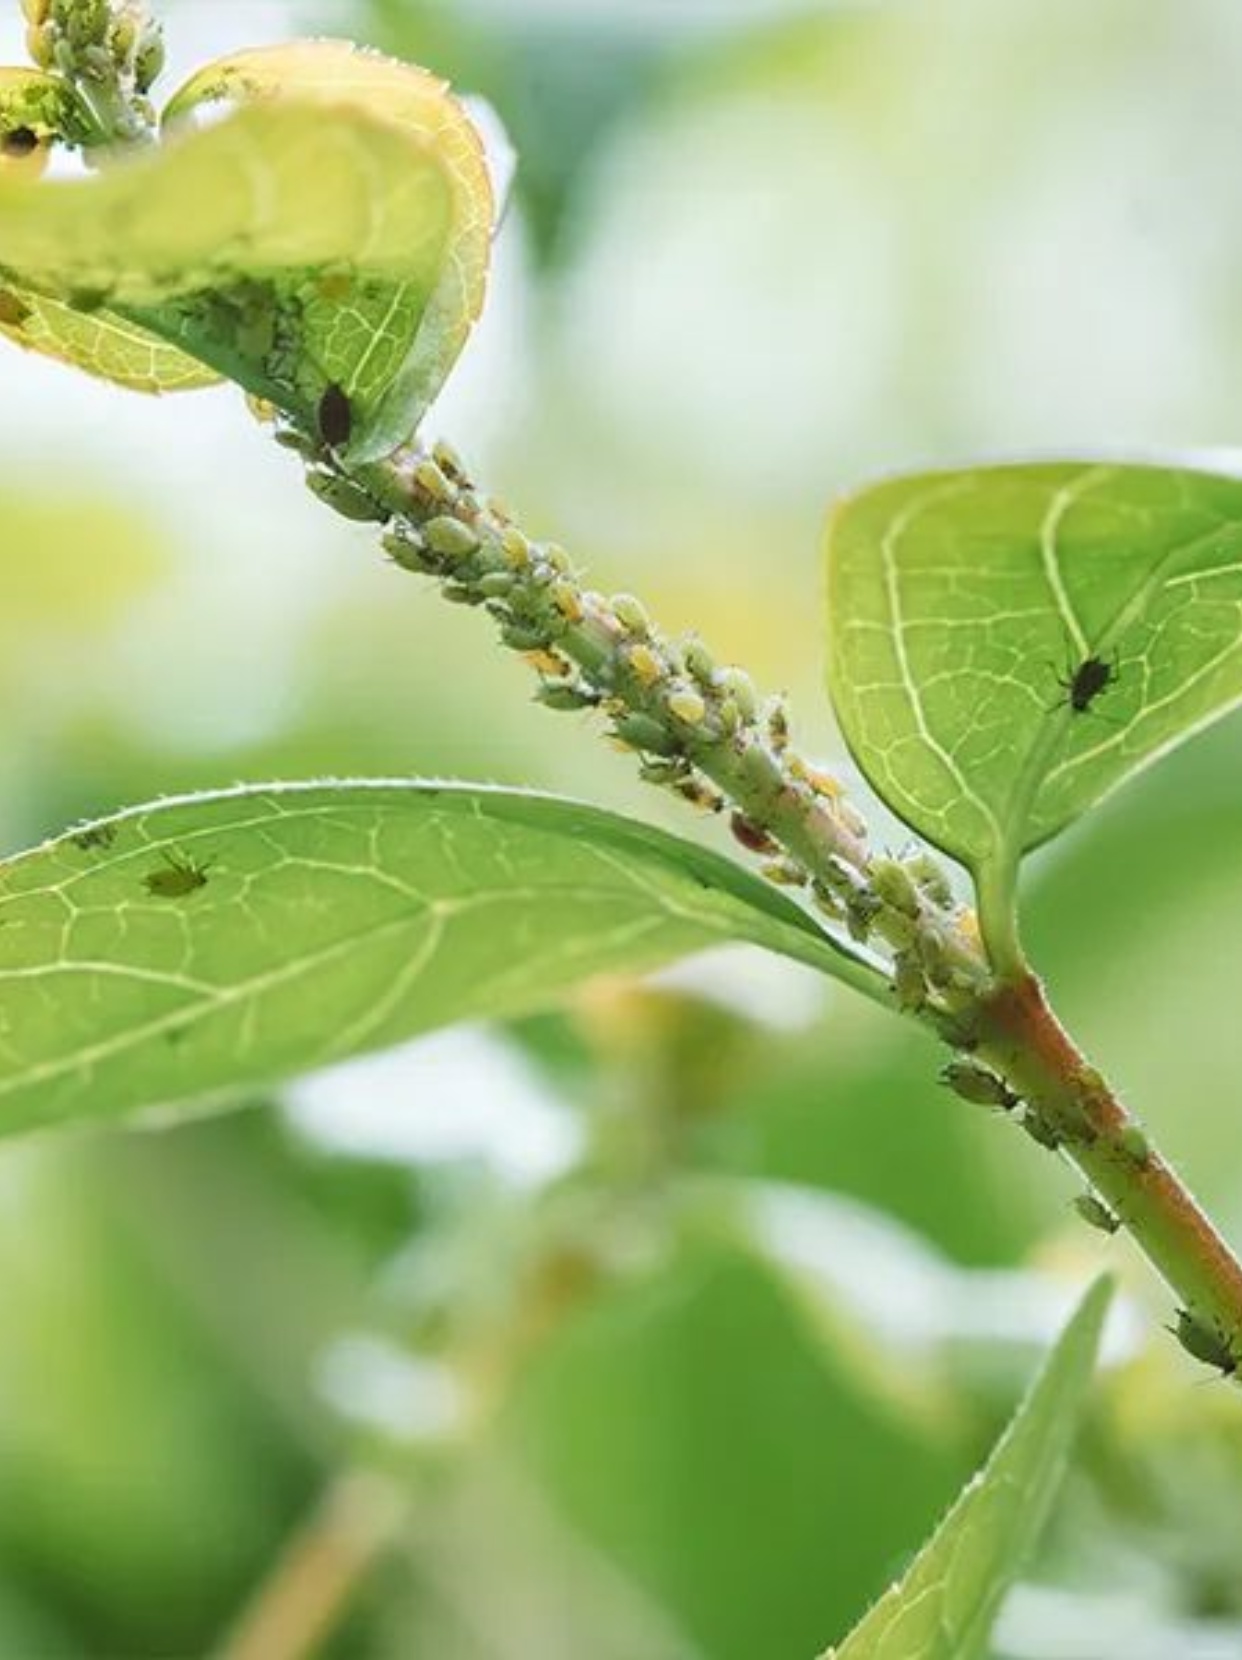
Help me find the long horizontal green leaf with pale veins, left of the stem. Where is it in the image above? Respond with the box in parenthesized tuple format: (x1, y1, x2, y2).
(0, 784, 845, 1132)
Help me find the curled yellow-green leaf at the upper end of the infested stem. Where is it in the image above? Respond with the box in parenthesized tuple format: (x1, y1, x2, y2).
(0, 42, 491, 460)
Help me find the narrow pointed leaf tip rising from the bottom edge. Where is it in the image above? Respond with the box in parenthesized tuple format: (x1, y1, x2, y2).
(824, 1278, 1112, 1660)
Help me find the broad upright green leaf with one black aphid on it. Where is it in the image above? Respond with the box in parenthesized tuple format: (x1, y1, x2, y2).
(827, 461, 1242, 873)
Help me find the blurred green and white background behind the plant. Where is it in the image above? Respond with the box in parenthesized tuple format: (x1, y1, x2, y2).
(0, 0, 1242, 1660)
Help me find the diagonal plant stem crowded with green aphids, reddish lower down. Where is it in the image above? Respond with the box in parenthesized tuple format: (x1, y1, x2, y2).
(317, 440, 1242, 1366)
